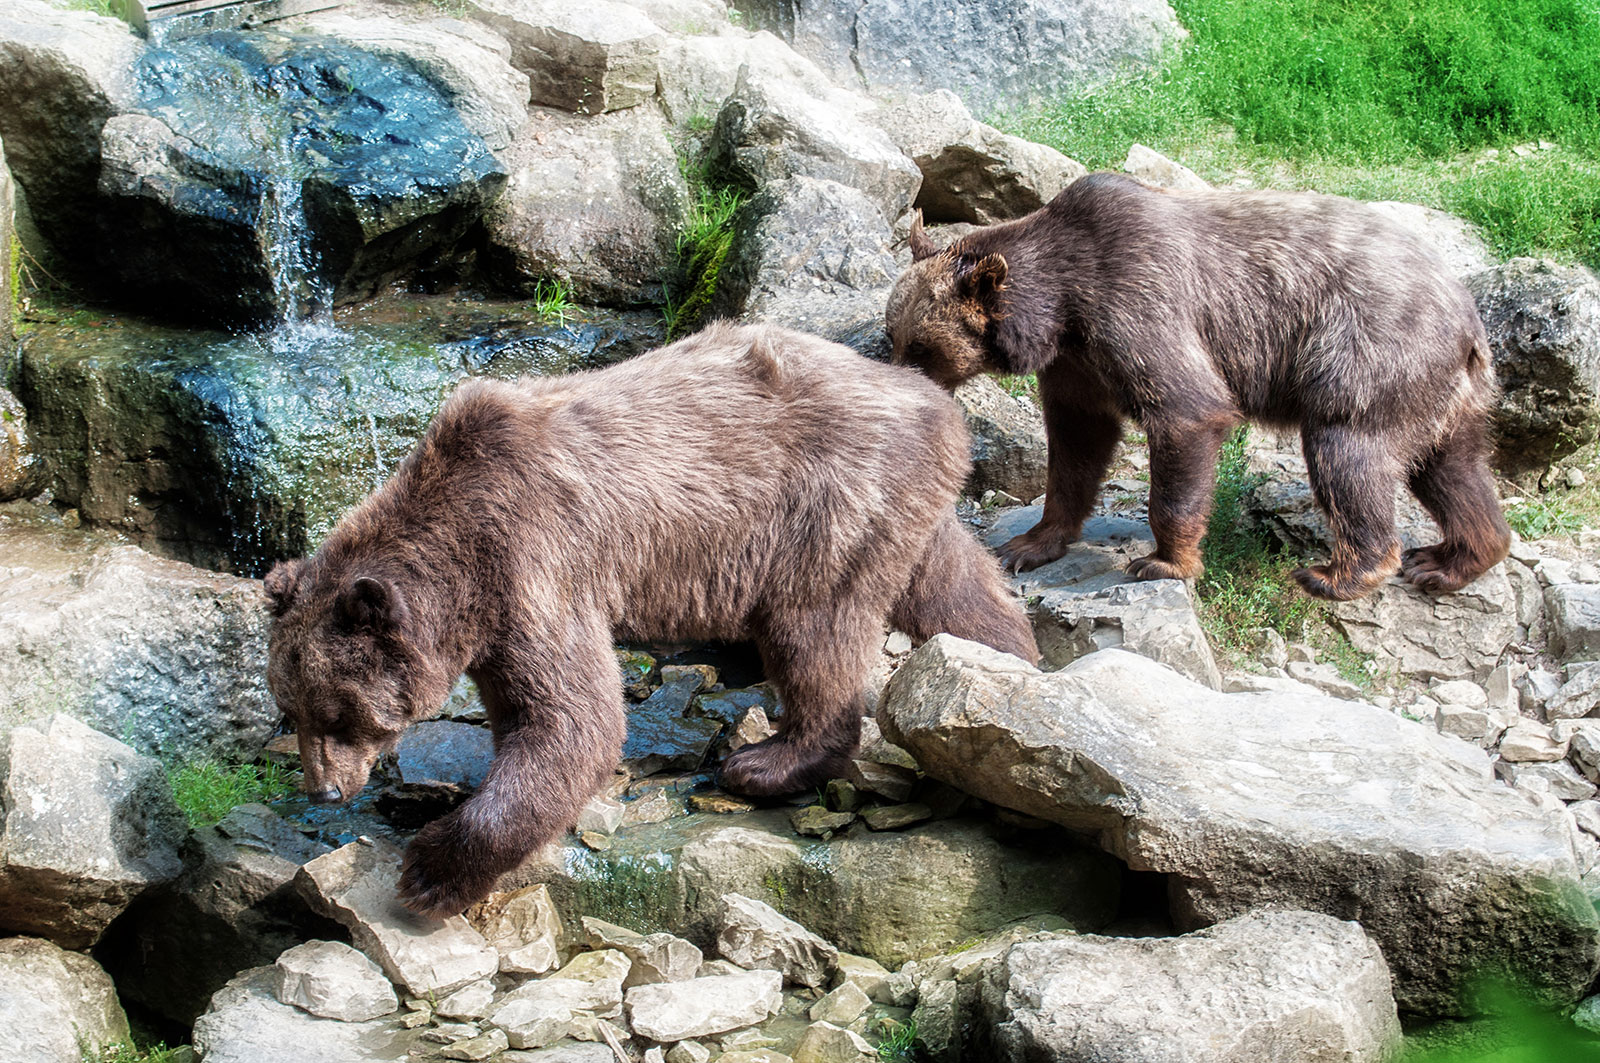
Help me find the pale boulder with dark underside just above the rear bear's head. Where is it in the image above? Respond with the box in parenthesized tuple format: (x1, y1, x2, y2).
(867, 88, 1088, 225)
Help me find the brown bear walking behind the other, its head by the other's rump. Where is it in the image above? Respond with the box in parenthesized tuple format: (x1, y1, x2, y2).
(886, 173, 1510, 599)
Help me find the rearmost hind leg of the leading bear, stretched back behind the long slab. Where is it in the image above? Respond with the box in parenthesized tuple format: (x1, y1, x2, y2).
(890, 509, 1038, 664)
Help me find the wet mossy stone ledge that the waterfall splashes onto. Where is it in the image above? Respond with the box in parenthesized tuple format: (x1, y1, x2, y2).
(18, 299, 650, 575)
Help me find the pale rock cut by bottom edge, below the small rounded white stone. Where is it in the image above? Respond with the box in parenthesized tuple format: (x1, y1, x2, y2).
(194, 967, 427, 1063)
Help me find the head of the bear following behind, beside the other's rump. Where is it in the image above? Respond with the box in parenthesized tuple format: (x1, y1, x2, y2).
(885, 211, 1008, 391)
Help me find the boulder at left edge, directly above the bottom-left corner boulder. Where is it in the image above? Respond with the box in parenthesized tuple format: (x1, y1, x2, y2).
(0, 714, 184, 949)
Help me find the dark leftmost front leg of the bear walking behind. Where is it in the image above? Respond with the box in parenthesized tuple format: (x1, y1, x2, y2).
(992, 359, 1122, 573)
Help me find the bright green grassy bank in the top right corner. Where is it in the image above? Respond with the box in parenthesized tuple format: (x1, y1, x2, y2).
(997, 0, 1600, 266)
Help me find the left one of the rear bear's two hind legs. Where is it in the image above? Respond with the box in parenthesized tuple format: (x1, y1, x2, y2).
(1293, 424, 1400, 602)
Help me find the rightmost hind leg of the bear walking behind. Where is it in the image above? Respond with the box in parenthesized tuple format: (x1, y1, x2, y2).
(1400, 423, 1510, 594)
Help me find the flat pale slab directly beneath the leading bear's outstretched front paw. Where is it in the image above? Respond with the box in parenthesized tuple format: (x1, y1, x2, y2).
(294, 842, 501, 997)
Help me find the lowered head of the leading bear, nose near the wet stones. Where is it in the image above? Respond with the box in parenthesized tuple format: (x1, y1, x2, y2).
(264, 560, 450, 802)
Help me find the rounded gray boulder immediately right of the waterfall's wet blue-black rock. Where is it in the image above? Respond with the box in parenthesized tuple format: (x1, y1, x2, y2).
(485, 107, 690, 306)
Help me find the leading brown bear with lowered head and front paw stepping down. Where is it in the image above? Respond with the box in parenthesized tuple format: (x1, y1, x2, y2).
(266, 325, 1038, 914)
